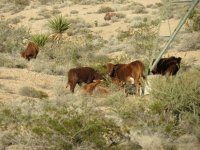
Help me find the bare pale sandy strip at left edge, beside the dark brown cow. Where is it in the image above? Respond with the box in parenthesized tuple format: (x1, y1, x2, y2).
(0, 67, 63, 101)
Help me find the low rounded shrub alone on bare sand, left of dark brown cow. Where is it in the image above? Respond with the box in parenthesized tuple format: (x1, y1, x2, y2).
(20, 87, 48, 99)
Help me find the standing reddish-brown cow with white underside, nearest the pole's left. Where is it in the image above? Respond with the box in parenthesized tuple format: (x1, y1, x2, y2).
(107, 60, 145, 95)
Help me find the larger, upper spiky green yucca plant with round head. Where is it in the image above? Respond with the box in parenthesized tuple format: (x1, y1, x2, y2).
(48, 15, 70, 33)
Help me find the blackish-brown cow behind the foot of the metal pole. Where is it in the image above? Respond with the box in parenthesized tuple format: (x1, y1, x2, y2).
(152, 56, 182, 75)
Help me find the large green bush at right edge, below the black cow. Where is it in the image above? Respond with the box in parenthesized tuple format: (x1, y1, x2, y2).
(150, 71, 200, 135)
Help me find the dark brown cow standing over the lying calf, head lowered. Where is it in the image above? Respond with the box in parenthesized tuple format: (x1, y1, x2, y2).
(66, 67, 103, 93)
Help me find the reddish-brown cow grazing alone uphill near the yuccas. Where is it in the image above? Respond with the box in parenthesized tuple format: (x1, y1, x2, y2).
(21, 42, 39, 61)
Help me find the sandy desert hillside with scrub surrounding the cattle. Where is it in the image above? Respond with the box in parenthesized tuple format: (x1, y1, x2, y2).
(0, 0, 200, 150)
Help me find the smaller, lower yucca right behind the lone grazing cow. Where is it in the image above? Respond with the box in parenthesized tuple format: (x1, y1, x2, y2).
(32, 34, 48, 47)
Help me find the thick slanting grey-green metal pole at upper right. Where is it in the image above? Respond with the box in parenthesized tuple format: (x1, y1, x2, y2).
(150, 0, 200, 72)
